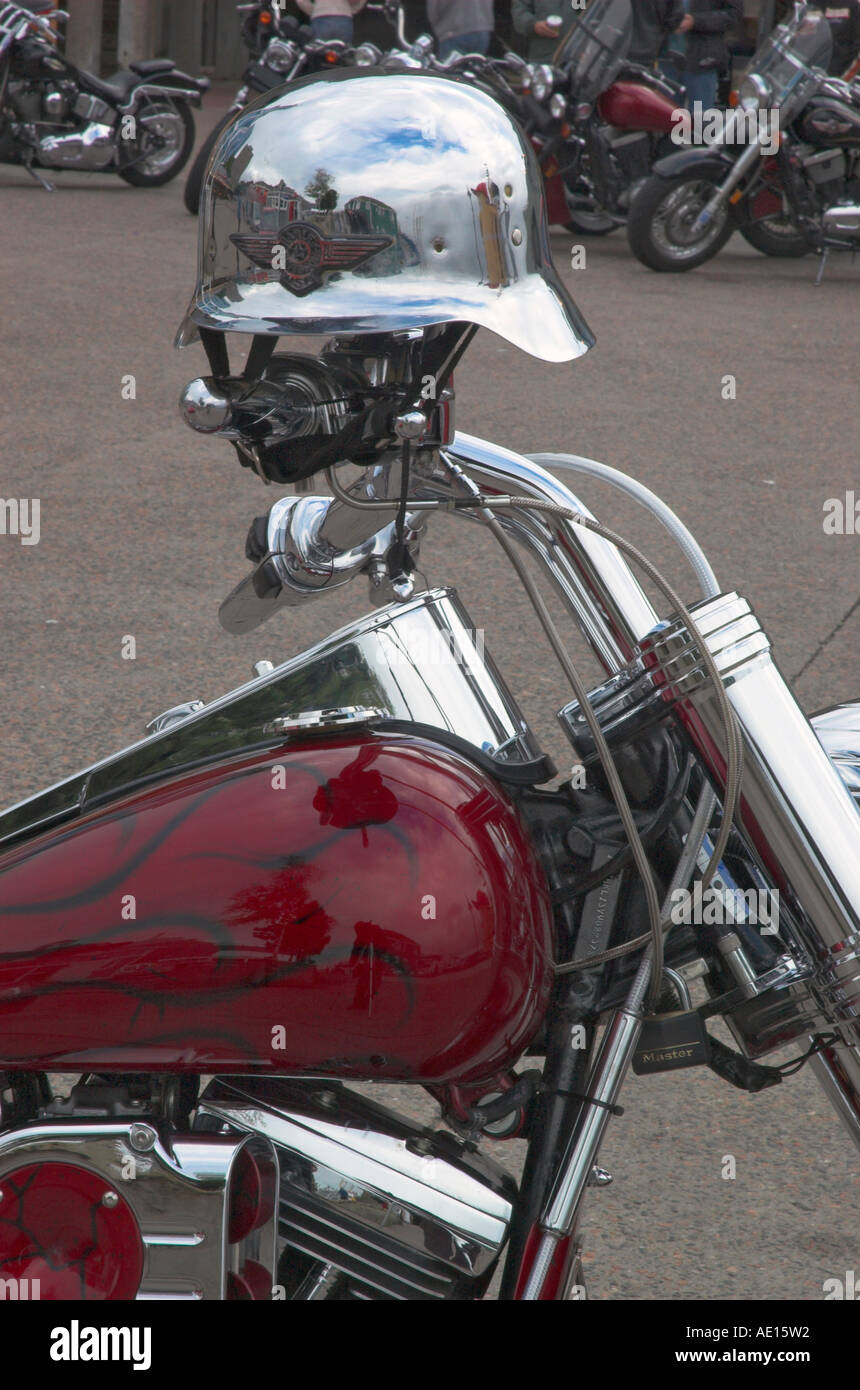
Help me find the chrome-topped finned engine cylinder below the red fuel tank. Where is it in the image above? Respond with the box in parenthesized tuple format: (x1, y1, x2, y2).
(197, 1077, 517, 1301)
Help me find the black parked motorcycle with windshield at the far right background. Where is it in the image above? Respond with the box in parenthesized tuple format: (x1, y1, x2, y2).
(628, 4, 860, 273)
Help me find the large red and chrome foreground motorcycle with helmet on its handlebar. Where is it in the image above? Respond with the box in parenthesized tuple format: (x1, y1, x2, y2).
(0, 72, 860, 1301)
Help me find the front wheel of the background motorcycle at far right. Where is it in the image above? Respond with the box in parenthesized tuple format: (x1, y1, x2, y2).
(627, 174, 736, 271)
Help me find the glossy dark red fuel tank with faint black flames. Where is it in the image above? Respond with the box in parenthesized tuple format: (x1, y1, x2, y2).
(0, 734, 552, 1081)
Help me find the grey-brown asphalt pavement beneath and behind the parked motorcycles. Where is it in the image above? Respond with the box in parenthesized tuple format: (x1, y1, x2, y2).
(0, 89, 860, 1300)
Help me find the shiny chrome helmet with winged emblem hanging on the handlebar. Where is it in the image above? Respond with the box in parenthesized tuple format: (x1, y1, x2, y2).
(176, 70, 593, 361)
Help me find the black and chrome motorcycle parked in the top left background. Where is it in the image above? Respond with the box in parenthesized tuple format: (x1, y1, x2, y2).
(0, 4, 208, 192)
